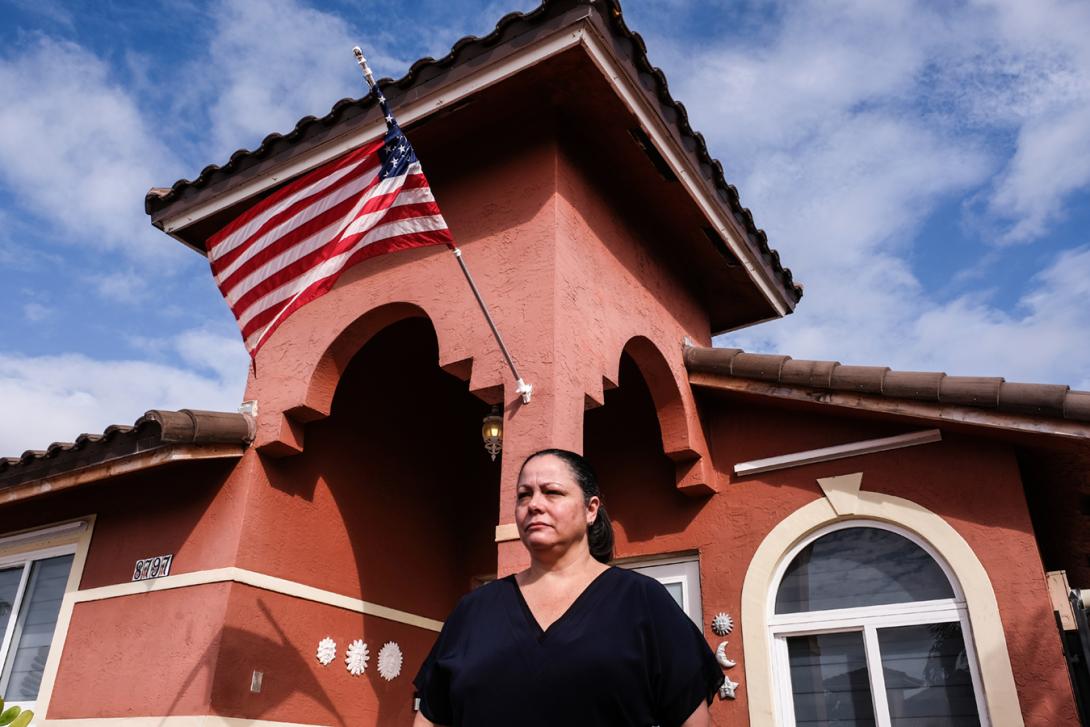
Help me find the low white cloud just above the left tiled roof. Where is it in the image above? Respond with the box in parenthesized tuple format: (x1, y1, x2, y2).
(0, 330, 249, 457)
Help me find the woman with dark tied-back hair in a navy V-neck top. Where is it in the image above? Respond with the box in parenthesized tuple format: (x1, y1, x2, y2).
(413, 449, 723, 727)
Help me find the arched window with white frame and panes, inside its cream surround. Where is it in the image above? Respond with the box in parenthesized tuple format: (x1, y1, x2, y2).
(767, 521, 988, 727)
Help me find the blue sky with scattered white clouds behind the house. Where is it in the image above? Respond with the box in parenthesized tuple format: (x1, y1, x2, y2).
(0, 0, 1090, 455)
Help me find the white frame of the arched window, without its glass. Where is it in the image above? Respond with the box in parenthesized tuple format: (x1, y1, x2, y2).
(766, 520, 991, 727)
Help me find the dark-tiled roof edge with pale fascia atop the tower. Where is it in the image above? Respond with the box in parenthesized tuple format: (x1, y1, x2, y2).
(147, 0, 801, 329)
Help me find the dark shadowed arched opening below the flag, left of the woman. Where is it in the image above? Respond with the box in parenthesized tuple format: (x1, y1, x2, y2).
(307, 318, 499, 619)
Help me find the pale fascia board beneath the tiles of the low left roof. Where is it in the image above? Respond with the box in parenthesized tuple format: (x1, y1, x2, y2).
(0, 445, 245, 505)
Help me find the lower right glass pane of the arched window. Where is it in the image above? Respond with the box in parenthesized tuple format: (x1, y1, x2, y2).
(879, 621, 980, 727)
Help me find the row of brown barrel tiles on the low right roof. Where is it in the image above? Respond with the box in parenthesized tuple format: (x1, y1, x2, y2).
(685, 346, 1090, 422)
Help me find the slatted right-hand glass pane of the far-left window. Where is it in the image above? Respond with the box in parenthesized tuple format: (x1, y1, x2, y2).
(3, 555, 73, 702)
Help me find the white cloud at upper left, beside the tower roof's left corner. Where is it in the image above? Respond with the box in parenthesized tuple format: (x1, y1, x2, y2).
(0, 37, 183, 259)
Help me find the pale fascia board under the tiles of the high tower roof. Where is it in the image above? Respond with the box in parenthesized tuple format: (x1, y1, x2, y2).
(161, 26, 788, 316)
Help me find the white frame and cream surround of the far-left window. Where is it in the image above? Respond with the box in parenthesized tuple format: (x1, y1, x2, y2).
(0, 517, 94, 724)
